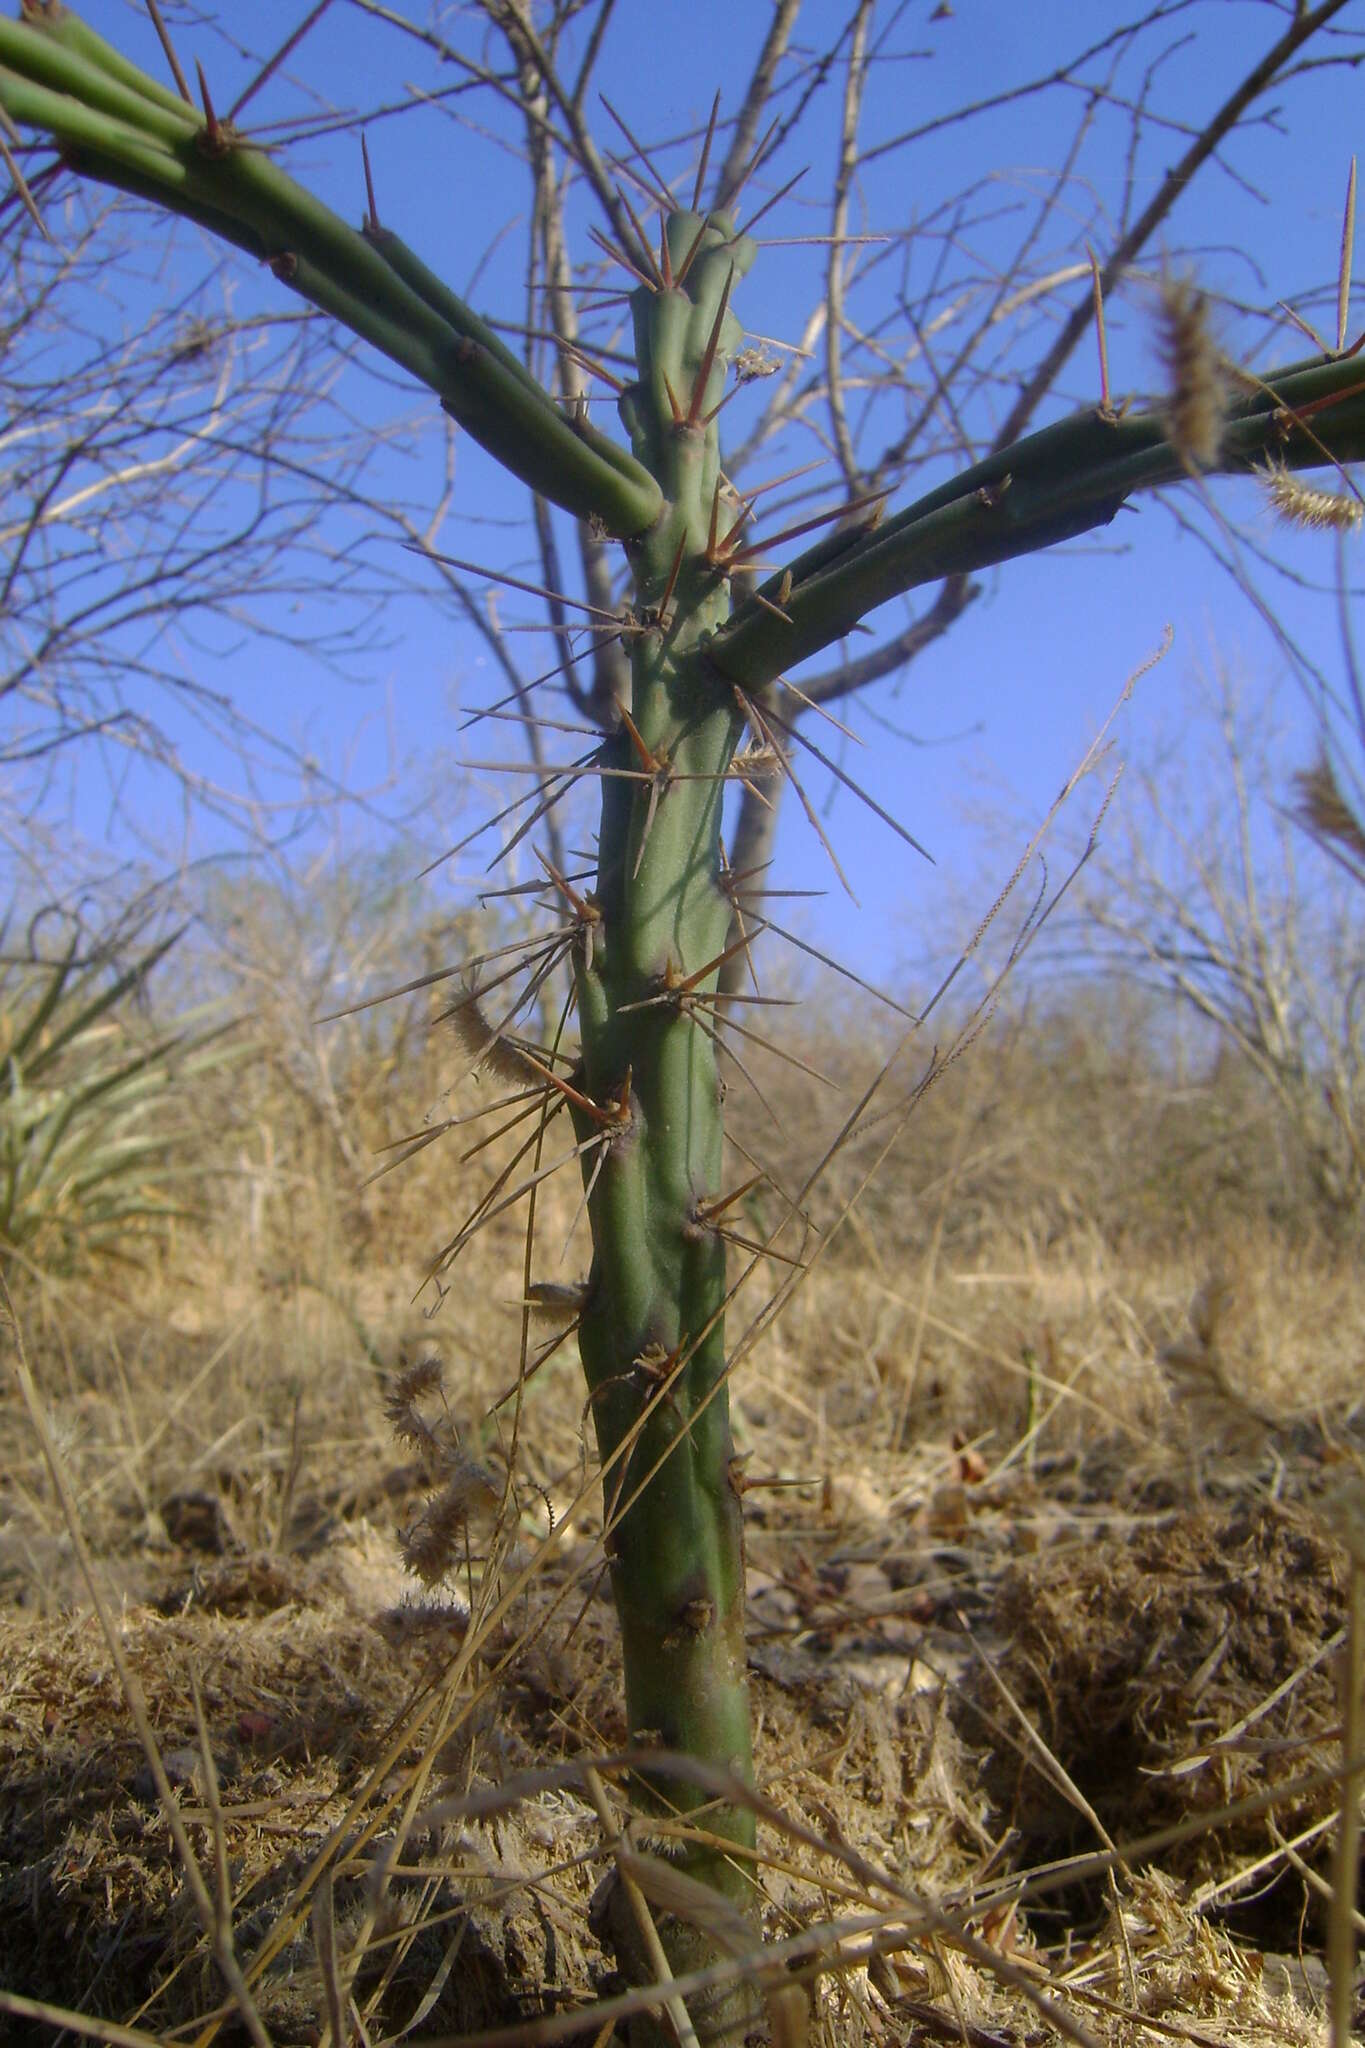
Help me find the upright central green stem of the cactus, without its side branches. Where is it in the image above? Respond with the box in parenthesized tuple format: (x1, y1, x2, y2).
(577, 213, 769, 2025)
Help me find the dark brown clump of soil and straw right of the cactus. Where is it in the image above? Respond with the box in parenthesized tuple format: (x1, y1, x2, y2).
(962, 1501, 1349, 1908)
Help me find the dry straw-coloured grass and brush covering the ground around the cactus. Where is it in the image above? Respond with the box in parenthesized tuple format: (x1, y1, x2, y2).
(0, 918, 1365, 2048)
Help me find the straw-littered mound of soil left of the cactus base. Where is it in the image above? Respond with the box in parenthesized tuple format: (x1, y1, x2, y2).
(0, 1540, 609, 2042)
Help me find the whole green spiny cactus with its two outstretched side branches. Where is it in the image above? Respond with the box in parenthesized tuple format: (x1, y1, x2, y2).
(0, 12, 1365, 2030)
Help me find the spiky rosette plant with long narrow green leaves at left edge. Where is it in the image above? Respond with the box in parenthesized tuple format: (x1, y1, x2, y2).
(0, 934, 233, 1272)
